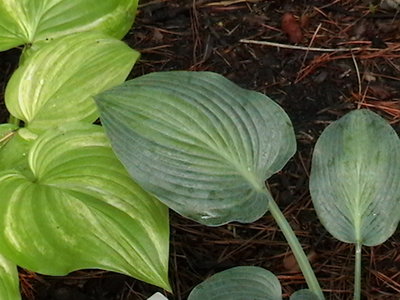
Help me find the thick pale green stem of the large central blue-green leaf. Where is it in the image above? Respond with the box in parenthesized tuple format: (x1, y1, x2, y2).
(269, 199, 325, 300)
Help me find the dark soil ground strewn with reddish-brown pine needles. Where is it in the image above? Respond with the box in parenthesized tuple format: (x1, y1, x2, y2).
(0, 0, 400, 300)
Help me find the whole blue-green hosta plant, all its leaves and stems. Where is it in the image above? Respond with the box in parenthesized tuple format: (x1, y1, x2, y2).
(95, 71, 400, 300)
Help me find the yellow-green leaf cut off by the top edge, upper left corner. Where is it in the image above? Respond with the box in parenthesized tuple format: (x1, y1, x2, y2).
(0, 0, 138, 51)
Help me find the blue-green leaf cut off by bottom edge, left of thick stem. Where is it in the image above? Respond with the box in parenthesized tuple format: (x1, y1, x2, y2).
(188, 267, 282, 300)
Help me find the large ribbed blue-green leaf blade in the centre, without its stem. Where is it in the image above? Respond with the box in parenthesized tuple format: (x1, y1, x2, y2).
(96, 71, 295, 225)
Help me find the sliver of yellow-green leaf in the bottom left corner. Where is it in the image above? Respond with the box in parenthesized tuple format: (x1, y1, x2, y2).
(0, 255, 21, 300)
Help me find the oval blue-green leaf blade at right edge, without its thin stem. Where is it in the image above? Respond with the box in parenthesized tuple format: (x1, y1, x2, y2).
(310, 110, 400, 246)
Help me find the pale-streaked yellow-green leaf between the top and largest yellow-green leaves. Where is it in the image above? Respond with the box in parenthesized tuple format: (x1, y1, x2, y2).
(5, 33, 139, 131)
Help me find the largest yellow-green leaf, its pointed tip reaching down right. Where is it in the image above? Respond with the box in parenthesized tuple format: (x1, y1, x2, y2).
(0, 123, 169, 289)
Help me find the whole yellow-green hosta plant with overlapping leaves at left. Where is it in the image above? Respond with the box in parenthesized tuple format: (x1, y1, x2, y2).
(0, 0, 170, 300)
